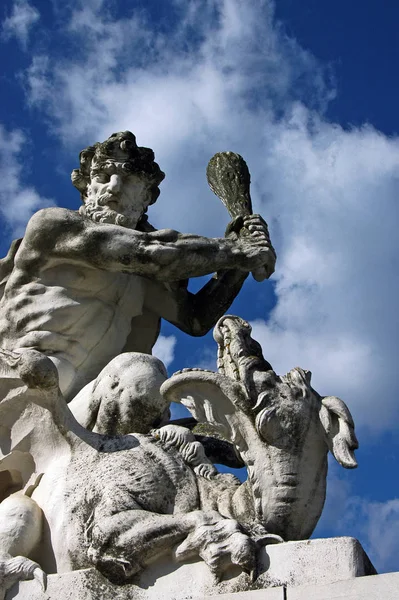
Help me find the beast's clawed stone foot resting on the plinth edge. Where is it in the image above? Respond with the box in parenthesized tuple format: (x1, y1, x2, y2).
(175, 519, 256, 580)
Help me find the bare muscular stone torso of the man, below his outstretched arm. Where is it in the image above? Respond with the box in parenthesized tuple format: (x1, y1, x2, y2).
(0, 210, 167, 392)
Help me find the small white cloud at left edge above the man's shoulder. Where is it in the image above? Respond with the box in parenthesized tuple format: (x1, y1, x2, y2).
(0, 124, 54, 237)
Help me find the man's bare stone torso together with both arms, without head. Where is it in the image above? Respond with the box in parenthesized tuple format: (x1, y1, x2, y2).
(0, 208, 247, 398)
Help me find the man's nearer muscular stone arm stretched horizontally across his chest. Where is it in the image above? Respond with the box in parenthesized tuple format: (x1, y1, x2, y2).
(24, 209, 270, 281)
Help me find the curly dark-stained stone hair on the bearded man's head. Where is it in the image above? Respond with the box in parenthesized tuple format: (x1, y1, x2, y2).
(71, 131, 165, 204)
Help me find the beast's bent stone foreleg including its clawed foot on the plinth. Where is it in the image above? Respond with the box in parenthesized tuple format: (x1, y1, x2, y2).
(87, 505, 256, 584)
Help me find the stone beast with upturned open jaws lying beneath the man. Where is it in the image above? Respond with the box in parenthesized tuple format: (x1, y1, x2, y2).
(0, 316, 357, 589)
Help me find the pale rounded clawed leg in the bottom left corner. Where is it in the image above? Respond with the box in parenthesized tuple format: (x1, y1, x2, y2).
(0, 492, 46, 600)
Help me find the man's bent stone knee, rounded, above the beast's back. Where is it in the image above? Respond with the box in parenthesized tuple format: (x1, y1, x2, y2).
(69, 352, 169, 435)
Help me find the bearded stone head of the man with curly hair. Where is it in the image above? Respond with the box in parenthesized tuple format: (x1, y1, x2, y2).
(72, 131, 165, 228)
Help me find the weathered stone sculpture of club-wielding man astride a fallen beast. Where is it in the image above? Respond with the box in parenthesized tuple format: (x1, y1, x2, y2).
(0, 132, 357, 600)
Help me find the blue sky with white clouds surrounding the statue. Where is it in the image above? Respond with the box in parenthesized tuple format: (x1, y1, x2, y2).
(0, 0, 399, 571)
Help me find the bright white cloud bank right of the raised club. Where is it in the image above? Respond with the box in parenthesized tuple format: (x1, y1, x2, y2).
(254, 113, 399, 427)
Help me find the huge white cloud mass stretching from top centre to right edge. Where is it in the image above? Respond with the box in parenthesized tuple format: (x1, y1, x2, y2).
(21, 0, 399, 431)
